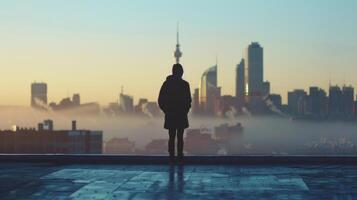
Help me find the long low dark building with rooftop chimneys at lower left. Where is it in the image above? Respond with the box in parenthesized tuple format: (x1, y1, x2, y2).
(0, 120, 103, 154)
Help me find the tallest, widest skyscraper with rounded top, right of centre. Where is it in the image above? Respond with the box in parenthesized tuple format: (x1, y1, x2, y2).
(244, 42, 263, 96)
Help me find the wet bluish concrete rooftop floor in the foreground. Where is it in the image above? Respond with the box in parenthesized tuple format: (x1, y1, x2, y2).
(0, 162, 357, 200)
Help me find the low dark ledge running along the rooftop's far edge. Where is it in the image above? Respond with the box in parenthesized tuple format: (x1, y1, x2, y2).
(0, 154, 357, 165)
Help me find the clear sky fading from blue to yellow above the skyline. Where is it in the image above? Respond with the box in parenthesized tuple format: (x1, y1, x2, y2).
(0, 0, 357, 105)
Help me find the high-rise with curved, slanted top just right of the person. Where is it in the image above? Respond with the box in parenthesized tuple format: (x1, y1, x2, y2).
(199, 65, 221, 114)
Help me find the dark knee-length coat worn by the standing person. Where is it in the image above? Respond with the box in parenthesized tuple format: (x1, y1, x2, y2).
(158, 75, 192, 129)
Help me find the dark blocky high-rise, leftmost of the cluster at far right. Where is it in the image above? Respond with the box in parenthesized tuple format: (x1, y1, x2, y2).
(288, 89, 306, 116)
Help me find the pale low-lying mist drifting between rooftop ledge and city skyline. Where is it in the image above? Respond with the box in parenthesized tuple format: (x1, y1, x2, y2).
(0, 106, 357, 155)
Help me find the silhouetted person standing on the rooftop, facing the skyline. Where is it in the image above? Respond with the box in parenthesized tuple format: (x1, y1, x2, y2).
(158, 63, 192, 161)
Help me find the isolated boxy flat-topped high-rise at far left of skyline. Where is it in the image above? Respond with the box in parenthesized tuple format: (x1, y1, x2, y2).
(31, 82, 47, 108)
